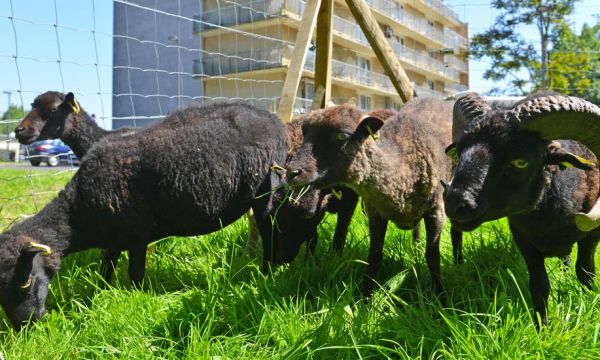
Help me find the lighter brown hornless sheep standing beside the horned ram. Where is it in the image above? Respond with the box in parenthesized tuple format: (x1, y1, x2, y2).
(287, 99, 452, 295)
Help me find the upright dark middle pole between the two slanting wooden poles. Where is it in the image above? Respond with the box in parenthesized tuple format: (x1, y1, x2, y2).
(311, 0, 333, 110)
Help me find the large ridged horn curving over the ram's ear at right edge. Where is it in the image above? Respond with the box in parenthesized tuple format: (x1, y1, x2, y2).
(513, 95, 600, 158)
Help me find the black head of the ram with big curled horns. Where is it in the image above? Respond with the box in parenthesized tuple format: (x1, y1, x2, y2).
(445, 94, 600, 231)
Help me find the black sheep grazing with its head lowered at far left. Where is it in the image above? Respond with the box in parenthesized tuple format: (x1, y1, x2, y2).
(0, 103, 288, 327)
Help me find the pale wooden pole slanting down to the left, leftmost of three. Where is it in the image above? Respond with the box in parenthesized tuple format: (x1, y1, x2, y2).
(277, 0, 321, 122)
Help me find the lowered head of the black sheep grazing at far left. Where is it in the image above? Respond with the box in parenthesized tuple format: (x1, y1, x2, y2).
(0, 234, 58, 329)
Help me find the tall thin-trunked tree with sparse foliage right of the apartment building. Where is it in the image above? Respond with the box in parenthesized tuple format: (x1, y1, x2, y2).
(470, 0, 579, 95)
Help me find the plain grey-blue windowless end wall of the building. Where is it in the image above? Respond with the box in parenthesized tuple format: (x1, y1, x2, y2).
(112, 0, 202, 129)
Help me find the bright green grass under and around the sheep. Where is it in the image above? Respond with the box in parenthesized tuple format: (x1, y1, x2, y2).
(0, 170, 600, 359)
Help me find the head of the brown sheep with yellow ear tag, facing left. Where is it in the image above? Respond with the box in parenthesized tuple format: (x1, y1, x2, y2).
(286, 105, 383, 188)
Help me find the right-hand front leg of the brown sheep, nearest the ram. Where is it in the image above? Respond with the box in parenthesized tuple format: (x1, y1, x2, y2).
(424, 208, 444, 302)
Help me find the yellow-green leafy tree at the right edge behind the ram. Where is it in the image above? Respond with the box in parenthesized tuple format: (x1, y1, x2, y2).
(549, 18, 600, 104)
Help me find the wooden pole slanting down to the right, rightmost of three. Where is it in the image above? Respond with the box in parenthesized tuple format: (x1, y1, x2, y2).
(346, 0, 414, 102)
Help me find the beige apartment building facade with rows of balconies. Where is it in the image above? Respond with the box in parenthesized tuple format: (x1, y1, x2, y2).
(194, 0, 469, 113)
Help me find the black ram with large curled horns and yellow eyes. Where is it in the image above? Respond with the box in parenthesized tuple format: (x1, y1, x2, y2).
(445, 93, 600, 327)
